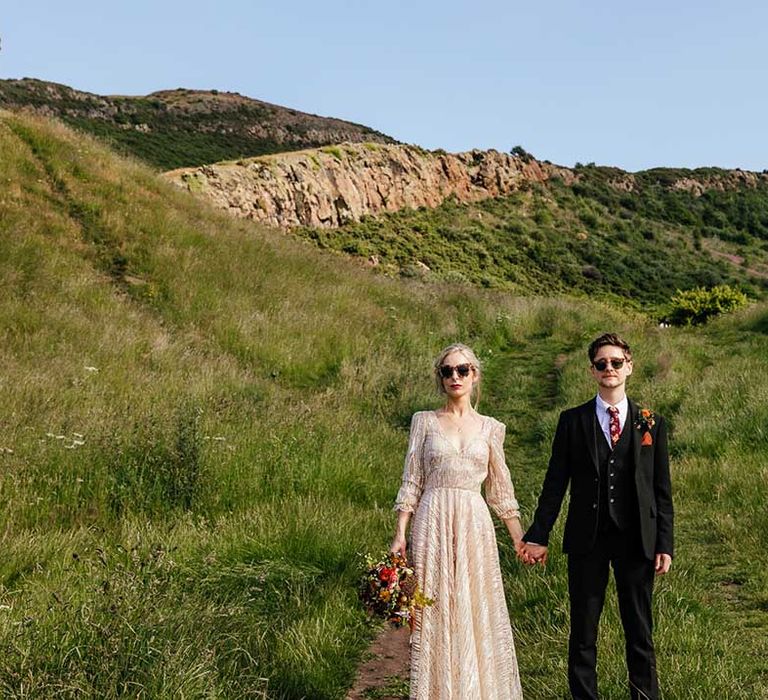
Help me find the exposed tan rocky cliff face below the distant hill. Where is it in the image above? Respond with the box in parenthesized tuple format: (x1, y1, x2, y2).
(165, 143, 574, 227)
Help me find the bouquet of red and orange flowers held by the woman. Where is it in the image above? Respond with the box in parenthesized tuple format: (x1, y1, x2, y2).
(359, 552, 434, 627)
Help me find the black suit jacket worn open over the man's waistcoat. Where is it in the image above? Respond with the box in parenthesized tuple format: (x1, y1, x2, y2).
(523, 399, 674, 559)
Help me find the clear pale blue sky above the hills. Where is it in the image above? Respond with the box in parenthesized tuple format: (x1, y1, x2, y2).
(0, 0, 768, 170)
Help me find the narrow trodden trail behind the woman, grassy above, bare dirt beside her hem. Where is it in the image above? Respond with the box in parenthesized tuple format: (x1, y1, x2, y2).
(346, 337, 570, 700)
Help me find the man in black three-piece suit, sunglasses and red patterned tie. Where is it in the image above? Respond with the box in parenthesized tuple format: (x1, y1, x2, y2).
(520, 333, 673, 700)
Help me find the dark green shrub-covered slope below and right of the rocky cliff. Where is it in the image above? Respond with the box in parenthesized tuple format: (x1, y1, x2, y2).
(297, 167, 768, 315)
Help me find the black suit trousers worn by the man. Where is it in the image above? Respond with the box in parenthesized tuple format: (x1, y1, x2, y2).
(568, 525, 659, 700)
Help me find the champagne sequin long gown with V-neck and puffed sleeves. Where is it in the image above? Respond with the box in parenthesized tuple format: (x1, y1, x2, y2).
(395, 411, 523, 700)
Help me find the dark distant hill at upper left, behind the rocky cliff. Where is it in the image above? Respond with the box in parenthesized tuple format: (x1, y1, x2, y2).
(0, 78, 395, 170)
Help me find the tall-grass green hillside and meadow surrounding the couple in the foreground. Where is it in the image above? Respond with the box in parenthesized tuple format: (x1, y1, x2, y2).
(0, 113, 768, 700)
